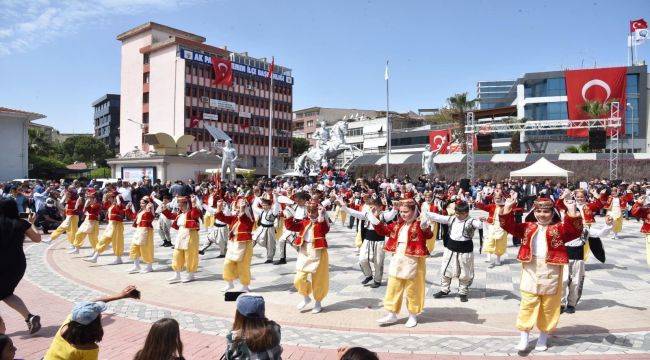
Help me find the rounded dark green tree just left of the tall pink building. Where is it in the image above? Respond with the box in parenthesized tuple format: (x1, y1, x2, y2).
(61, 135, 114, 166)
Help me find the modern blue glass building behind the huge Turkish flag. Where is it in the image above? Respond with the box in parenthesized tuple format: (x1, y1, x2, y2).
(512, 65, 650, 153)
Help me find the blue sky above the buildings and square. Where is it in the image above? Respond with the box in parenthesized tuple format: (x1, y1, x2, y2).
(0, 0, 650, 133)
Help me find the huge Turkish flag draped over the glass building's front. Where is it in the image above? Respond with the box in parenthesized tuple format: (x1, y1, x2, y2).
(564, 67, 627, 137)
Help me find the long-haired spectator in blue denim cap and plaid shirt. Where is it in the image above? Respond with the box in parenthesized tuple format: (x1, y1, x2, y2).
(225, 293, 282, 360)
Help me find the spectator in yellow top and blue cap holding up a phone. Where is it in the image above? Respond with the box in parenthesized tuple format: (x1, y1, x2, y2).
(45, 286, 140, 360)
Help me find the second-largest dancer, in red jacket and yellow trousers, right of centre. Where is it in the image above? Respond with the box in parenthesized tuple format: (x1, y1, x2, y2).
(369, 199, 432, 327)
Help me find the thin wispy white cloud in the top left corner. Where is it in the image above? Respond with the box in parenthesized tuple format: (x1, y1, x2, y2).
(0, 0, 200, 56)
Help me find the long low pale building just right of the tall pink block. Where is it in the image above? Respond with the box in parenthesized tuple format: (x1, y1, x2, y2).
(293, 106, 378, 145)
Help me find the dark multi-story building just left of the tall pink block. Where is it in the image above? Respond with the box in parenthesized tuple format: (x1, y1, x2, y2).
(92, 94, 120, 153)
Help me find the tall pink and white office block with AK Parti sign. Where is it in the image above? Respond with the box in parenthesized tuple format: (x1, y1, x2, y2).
(117, 22, 293, 169)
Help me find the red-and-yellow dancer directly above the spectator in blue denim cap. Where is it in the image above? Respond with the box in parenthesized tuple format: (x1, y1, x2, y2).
(214, 199, 254, 291)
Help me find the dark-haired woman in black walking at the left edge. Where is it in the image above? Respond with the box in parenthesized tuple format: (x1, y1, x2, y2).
(0, 199, 41, 334)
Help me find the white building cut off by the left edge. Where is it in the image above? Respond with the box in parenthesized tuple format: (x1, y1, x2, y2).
(0, 107, 45, 181)
